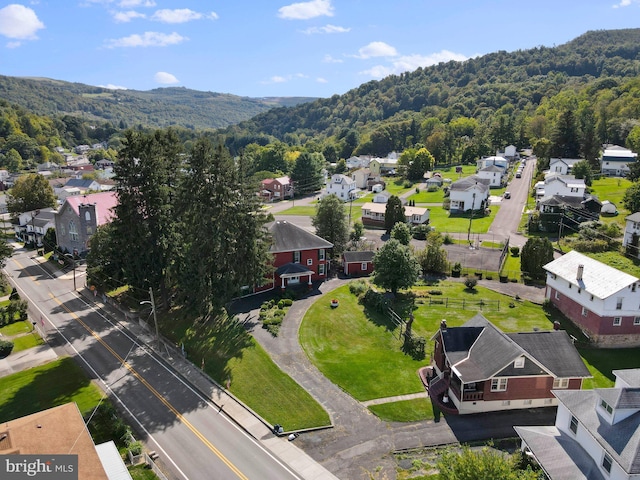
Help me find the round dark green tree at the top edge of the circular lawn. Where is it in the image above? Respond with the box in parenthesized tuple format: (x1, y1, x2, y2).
(373, 238, 420, 294)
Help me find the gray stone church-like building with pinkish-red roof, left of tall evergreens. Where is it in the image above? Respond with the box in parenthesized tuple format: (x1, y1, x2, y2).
(55, 192, 118, 256)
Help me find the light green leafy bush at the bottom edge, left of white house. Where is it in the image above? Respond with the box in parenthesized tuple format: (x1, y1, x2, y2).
(437, 445, 538, 480)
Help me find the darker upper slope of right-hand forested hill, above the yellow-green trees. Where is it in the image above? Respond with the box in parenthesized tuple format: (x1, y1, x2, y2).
(226, 29, 640, 153)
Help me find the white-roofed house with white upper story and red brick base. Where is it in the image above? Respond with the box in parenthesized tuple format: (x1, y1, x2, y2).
(544, 250, 640, 347)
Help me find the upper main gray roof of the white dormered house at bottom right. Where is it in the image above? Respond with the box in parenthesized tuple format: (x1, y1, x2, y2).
(553, 389, 640, 475)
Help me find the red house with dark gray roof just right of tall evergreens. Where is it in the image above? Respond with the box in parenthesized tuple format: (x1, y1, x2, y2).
(254, 221, 333, 292)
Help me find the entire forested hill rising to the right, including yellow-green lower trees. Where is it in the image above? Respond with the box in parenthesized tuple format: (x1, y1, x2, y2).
(225, 29, 640, 163)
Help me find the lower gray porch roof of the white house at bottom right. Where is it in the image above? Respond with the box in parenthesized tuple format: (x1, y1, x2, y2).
(513, 427, 604, 480)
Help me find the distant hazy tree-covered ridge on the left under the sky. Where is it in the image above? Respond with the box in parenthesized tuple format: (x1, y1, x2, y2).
(0, 76, 314, 130)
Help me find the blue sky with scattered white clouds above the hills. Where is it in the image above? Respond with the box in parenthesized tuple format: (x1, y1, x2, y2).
(0, 0, 640, 97)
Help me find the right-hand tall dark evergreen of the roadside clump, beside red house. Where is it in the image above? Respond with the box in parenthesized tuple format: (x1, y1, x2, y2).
(176, 137, 272, 319)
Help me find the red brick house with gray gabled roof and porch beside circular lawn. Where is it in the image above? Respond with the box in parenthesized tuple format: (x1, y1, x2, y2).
(429, 314, 591, 414)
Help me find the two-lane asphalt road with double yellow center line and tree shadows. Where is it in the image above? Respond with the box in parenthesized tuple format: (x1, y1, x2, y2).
(5, 250, 300, 480)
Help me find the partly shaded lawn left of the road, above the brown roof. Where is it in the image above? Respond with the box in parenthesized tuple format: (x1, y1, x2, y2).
(0, 357, 102, 422)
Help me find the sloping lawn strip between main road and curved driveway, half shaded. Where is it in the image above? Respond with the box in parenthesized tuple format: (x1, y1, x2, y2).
(159, 311, 330, 430)
